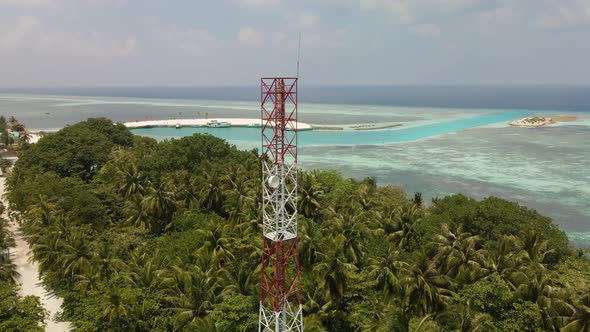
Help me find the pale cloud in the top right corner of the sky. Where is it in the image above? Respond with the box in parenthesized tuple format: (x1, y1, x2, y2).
(535, 0, 590, 29)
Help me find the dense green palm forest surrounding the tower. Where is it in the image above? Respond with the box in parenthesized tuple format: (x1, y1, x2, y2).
(0, 118, 590, 332)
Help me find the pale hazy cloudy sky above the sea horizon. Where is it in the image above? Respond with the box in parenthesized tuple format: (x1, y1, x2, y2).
(0, 0, 590, 88)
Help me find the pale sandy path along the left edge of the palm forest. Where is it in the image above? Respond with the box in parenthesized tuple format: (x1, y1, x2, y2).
(0, 177, 73, 332)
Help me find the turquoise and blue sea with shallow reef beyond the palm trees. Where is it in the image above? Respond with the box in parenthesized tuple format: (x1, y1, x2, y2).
(0, 87, 590, 246)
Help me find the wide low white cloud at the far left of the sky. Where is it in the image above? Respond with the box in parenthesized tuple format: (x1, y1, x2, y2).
(0, 16, 138, 58)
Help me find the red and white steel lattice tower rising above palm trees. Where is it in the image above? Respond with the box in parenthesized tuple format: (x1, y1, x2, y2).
(258, 77, 303, 332)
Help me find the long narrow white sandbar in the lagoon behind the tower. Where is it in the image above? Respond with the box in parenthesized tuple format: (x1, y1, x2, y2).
(124, 118, 312, 130)
